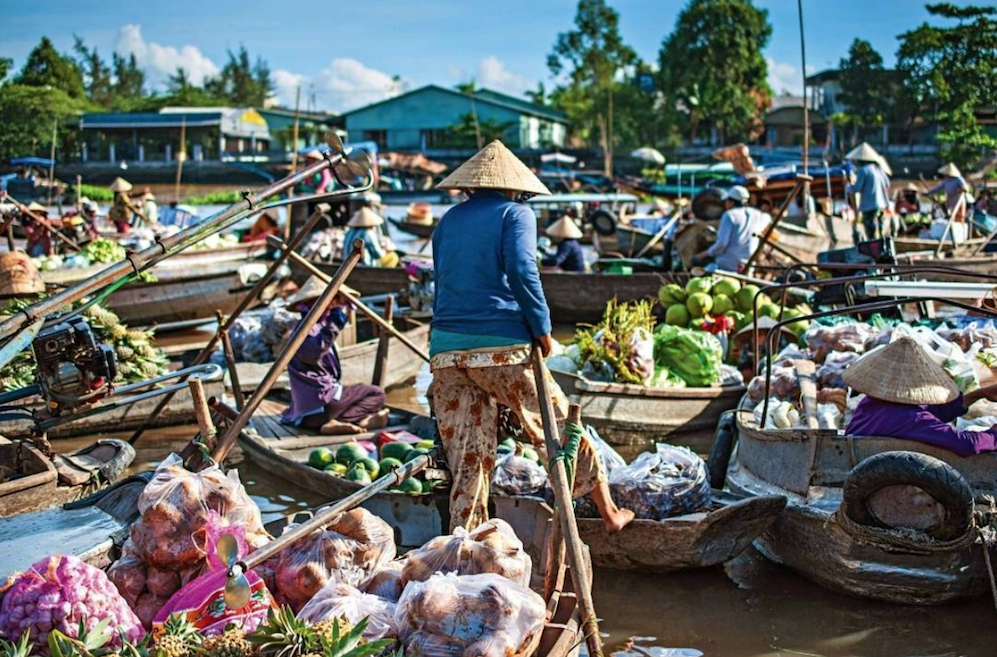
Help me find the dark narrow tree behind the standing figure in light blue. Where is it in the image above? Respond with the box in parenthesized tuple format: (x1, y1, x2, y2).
(838, 39, 891, 142)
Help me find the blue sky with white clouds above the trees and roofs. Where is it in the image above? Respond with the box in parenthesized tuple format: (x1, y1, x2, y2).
(0, 0, 986, 111)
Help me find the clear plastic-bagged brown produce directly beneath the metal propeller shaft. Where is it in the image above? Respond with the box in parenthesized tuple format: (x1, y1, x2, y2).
(256, 509, 395, 611)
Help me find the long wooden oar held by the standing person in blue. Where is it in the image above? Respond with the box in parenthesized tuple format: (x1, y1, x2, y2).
(532, 347, 603, 657)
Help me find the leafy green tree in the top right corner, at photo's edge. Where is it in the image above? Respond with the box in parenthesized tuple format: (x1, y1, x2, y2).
(897, 3, 997, 164)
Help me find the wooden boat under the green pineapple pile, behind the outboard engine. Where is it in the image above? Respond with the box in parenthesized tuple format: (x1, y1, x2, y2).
(3, 381, 225, 438)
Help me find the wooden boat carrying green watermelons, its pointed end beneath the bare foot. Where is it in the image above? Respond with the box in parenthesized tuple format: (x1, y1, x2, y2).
(239, 400, 785, 572)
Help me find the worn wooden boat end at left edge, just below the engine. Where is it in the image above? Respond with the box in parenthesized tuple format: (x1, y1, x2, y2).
(0, 438, 135, 517)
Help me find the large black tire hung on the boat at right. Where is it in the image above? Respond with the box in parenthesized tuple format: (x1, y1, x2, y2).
(841, 451, 973, 541)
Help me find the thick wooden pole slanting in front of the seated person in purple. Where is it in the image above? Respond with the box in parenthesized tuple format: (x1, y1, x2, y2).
(212, 239, 364, 463)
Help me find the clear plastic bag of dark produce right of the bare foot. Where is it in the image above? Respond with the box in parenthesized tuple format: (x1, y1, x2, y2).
(609, 443, 713, 520)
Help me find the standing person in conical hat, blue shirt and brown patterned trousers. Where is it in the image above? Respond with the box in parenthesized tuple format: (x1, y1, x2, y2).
(430, 140, 633, 531)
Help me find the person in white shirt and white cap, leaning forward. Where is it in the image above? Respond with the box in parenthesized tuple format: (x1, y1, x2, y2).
(693, 185, 771, 273)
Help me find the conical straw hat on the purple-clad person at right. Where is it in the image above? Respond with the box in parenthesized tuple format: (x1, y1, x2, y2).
(843, 336, 959, 405)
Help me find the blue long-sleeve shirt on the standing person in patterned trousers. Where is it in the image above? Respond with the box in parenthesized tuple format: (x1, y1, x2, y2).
(432, 190, 551, 342)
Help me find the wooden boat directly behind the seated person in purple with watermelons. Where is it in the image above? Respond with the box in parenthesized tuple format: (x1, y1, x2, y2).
(236, 318, 429, 393)
